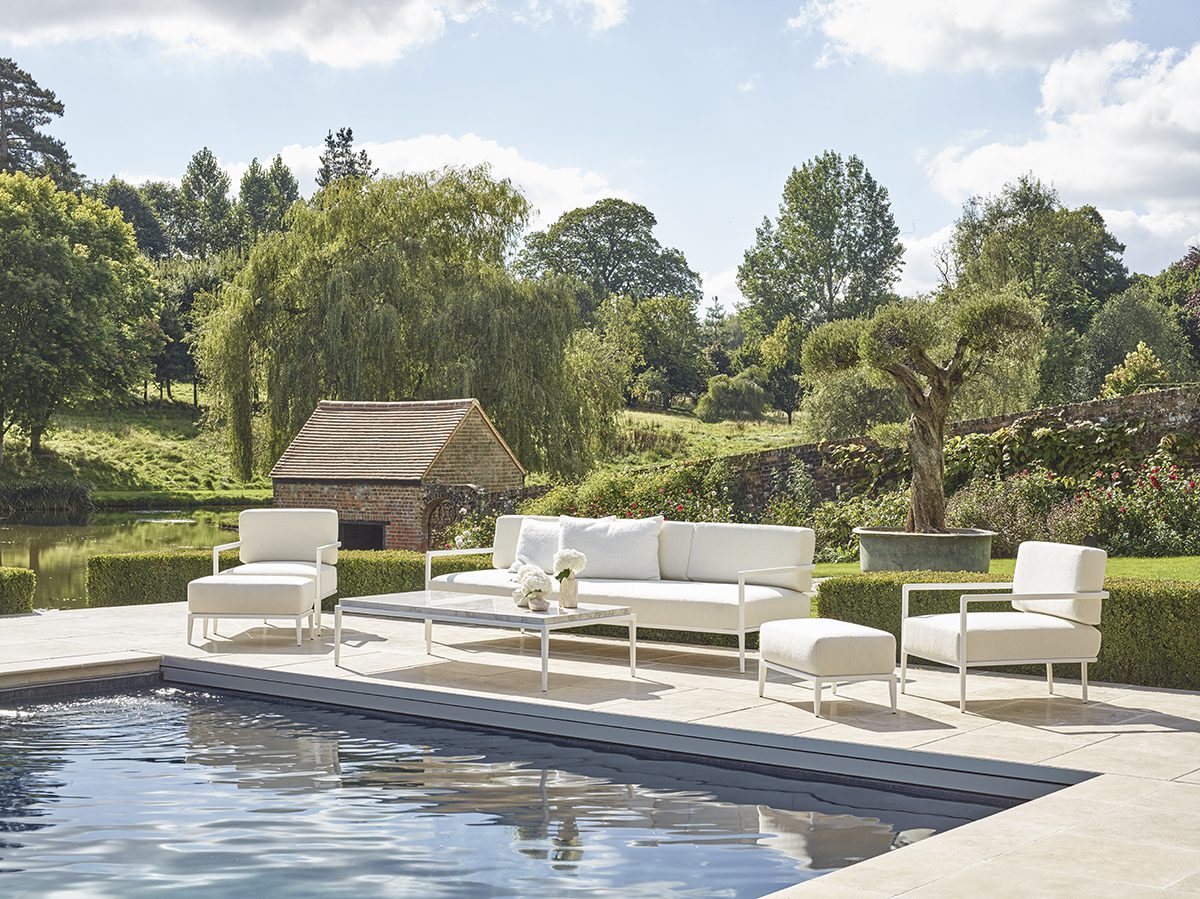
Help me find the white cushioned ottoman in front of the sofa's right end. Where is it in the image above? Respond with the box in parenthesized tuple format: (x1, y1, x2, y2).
(758, 618, 896, 718)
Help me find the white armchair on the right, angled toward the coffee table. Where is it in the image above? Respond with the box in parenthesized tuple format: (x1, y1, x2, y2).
(900, 541, 1109, 712)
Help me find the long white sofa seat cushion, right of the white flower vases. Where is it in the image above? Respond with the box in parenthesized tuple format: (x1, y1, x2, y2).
(580, 577, 809, 630)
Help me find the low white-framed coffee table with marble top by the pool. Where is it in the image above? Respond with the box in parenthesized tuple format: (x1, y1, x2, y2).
(334, 591, 637, 693)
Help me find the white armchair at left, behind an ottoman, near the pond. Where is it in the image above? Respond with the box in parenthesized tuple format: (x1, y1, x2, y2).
(212, 509, 342, 633)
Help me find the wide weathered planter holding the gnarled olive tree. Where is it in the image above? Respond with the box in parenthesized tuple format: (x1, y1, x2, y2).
(854, 528, 996, 571)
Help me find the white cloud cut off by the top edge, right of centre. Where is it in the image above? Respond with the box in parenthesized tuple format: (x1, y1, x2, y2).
(787, 0, 1130, 72)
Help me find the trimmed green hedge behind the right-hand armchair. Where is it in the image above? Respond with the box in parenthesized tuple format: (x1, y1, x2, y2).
(817, 571, 1200, 690)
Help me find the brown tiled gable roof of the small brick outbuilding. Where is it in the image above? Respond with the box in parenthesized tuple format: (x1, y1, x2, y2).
(271, 400, 520, 481)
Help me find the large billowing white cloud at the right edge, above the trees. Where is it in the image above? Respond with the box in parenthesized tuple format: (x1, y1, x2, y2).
(928, 42, 1200, 271)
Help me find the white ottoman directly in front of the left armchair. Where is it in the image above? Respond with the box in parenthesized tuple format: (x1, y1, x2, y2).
(187, 575, 317, 646)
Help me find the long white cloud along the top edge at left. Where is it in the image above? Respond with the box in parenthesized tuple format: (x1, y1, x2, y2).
(0, 0, 629, 68)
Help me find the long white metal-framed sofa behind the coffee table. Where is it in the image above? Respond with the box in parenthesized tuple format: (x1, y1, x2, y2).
(425, 515, 815, 671)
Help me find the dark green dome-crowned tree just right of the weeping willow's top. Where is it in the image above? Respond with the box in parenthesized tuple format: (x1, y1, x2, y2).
(516, 198, 701, 318)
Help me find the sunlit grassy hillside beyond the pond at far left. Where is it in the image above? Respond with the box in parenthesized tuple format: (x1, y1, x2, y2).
(0, 402, 271, 505)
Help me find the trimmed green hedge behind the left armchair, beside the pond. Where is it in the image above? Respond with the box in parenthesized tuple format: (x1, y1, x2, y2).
(88, 550, 492, 610)
